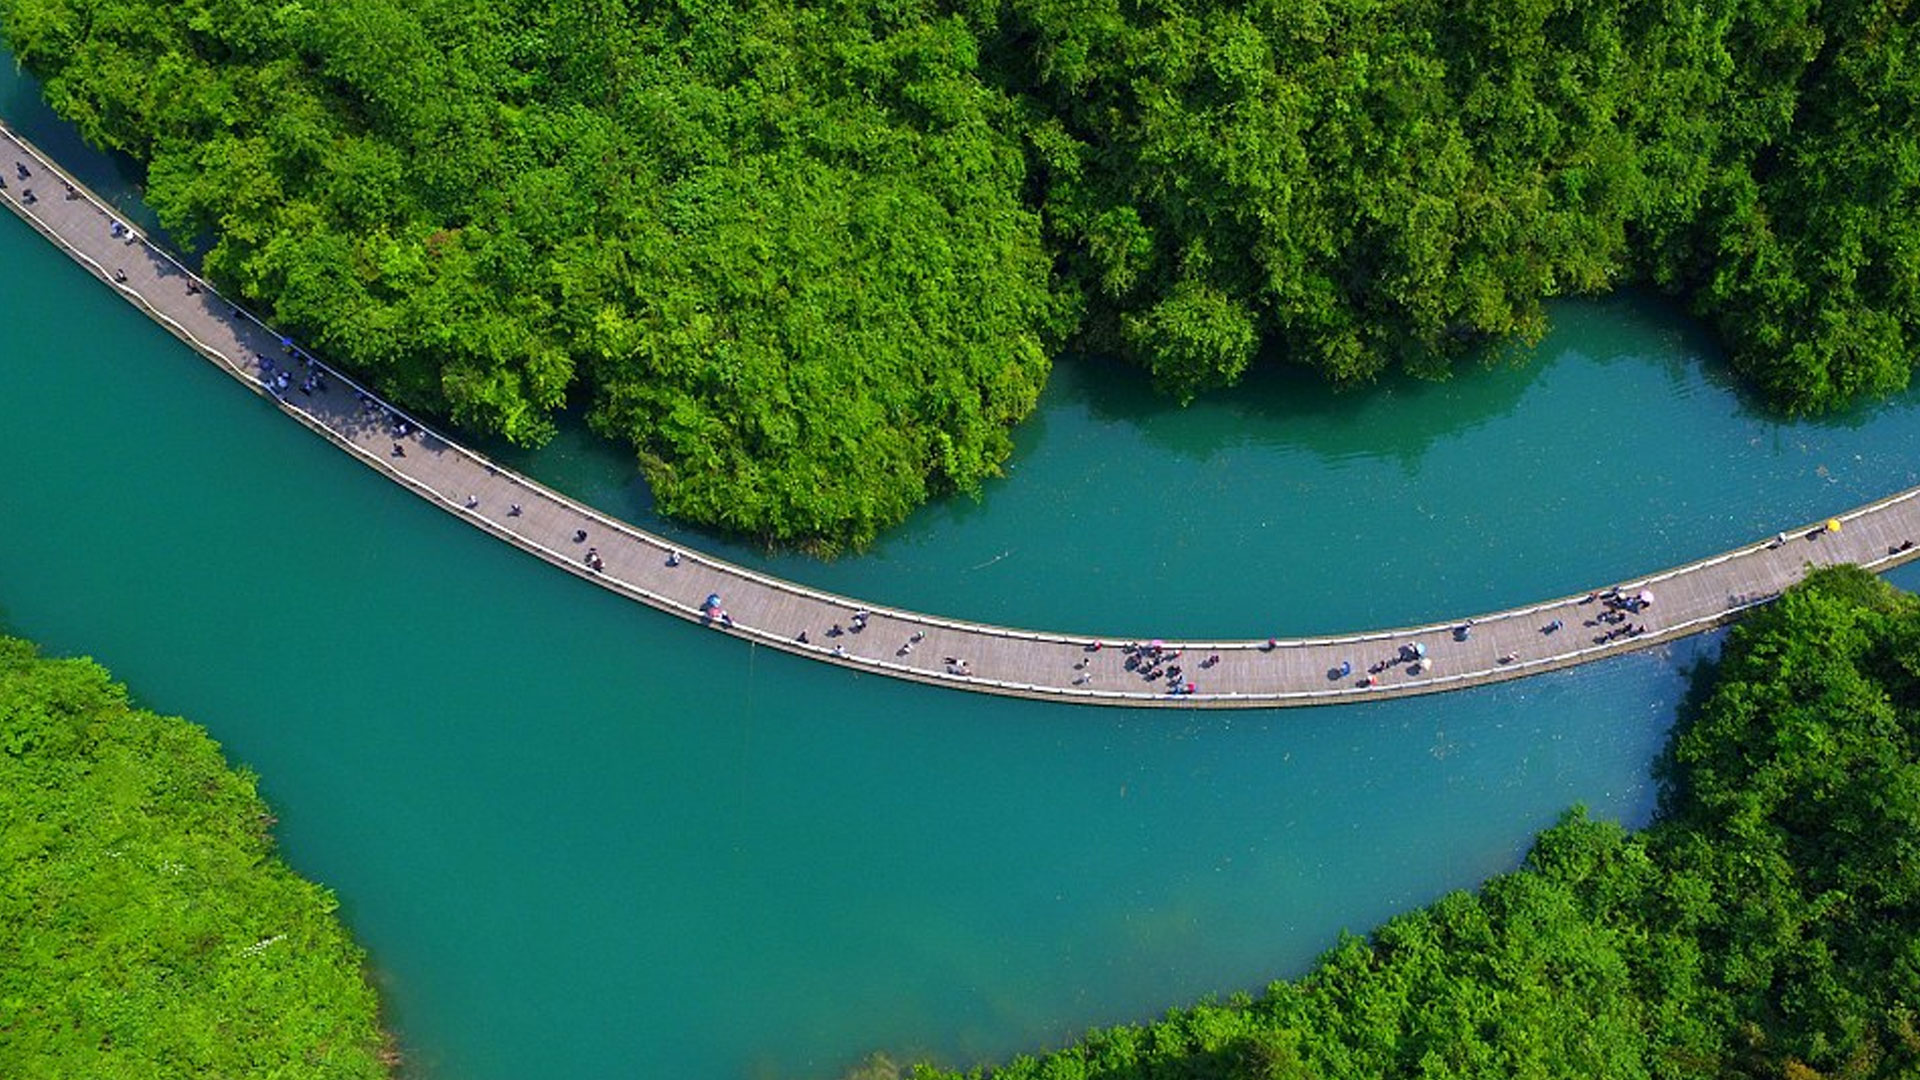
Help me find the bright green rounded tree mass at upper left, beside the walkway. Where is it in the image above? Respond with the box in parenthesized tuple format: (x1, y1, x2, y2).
(0, 0, 1064, 546)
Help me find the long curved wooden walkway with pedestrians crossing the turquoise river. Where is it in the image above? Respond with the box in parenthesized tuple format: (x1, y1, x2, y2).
(0, 119, 1920, 707)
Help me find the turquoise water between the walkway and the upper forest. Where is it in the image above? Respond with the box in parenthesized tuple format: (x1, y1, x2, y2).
(495, 296, 1920, 638)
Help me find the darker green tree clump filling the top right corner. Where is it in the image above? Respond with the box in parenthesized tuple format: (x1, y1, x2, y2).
(1661, 2, 1920, 411)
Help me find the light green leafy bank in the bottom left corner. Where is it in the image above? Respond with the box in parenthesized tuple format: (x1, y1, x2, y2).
(0, 638, 390, 1080)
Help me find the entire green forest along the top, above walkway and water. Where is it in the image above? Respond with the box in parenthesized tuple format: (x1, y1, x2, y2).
(0, 0, 1920, 548)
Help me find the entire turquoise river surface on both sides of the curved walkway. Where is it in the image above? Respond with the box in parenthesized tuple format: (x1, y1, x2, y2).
(11, 65, 1920, 1080)
